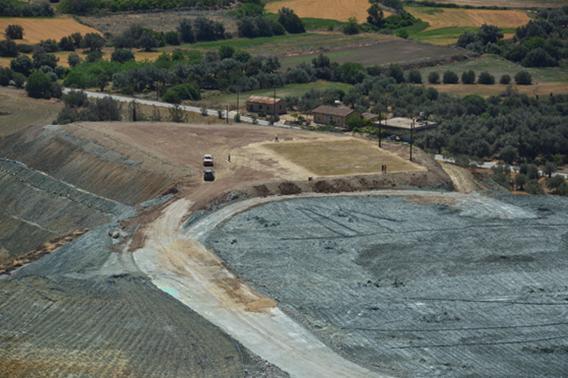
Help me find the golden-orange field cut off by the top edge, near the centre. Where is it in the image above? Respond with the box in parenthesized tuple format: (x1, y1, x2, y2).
(266, 0, 386, 22)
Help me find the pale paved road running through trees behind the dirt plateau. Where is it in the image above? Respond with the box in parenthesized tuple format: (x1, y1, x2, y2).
(63, 88, 297, 129)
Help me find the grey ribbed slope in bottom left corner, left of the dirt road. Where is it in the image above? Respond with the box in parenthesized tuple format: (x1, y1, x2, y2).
(0, 204, 285, 377)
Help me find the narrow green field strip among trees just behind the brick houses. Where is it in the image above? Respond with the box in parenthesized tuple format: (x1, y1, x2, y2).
(203, 80, 352, 107)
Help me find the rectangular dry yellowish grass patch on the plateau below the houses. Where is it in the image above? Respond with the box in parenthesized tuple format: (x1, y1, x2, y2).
(264, 138, 424, 176)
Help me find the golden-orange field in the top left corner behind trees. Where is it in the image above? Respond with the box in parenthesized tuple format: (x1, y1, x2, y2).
(0, 16, 98, 44)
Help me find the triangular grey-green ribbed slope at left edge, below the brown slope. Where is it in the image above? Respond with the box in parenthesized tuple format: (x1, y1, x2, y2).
(0, 159, 128, 266)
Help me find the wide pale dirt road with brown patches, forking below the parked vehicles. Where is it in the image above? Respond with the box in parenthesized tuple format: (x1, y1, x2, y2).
(134, 199, 388, 377)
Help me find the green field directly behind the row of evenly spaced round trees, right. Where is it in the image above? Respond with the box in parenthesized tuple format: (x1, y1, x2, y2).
(421, 54, 568, 83)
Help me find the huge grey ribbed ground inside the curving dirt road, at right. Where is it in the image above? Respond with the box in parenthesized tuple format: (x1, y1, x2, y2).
(207, 194, 568, 376)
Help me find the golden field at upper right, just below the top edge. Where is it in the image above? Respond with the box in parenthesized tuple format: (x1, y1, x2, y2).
(407, 7, 529, 29)
